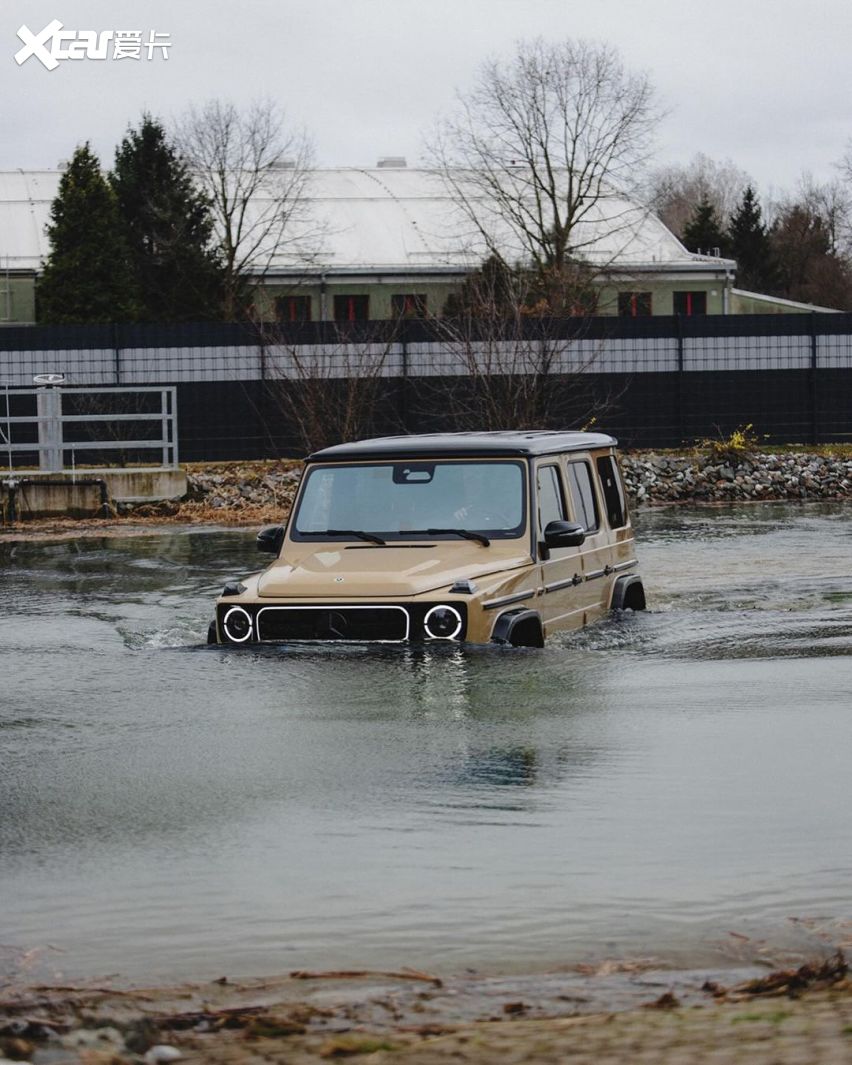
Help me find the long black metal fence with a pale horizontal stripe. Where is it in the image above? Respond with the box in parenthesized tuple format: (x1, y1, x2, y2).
(0, 314, 852, 459)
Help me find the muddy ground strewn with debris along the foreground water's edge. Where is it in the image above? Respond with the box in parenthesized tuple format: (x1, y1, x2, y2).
(0, 954, 852, 1065)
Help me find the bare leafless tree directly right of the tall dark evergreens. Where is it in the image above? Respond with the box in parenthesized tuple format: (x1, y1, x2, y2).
(176, 100, 317, 320)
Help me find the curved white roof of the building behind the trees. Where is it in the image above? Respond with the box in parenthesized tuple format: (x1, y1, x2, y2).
(0, 166, 734, 274)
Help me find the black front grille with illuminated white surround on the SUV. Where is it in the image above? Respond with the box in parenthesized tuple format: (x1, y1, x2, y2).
(258, 606, 409, 642)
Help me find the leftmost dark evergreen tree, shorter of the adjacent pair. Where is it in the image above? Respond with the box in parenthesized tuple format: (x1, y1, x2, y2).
(37, 144, 135, 325)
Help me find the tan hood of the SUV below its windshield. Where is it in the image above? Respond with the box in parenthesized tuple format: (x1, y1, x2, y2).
(258, 540, 530, 599)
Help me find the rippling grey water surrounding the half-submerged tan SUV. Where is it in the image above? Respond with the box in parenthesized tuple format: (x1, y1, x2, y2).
(0, 506, 852, 982)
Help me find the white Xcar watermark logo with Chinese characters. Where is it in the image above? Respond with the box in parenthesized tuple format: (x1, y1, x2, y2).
(15, 18, 171, 70)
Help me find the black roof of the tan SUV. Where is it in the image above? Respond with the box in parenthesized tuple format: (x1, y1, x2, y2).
(308, 429, 618, 462)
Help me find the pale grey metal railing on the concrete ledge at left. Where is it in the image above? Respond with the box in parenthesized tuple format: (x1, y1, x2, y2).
(0, 384, 178, 473)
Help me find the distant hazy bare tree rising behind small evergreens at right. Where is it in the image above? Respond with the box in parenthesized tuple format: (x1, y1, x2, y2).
(642, 152, 754, 240)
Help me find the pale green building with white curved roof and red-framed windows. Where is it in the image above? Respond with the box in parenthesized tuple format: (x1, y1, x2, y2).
(0, 159, 839, 324)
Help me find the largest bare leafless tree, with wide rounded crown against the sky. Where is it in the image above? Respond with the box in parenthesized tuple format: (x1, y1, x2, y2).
(427, 39, 659, 272)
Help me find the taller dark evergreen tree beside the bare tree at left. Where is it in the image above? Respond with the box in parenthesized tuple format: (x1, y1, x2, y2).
(110, 115, 222, 322)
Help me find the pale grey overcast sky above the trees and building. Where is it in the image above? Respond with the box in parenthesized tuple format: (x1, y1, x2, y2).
(0, 0, 852, 195)
